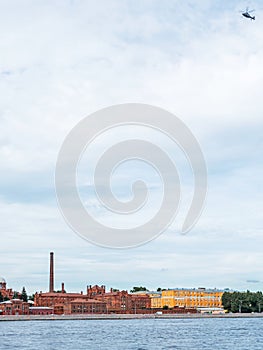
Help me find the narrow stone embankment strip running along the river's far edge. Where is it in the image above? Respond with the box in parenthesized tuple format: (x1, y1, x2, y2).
(0, 313, 263, 322)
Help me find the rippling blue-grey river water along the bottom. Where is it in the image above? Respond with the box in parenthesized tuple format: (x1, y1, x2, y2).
(0, 318, 263, 350)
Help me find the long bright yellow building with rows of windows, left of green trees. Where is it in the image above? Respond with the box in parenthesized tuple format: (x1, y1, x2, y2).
(161, 288, 224, 308)
